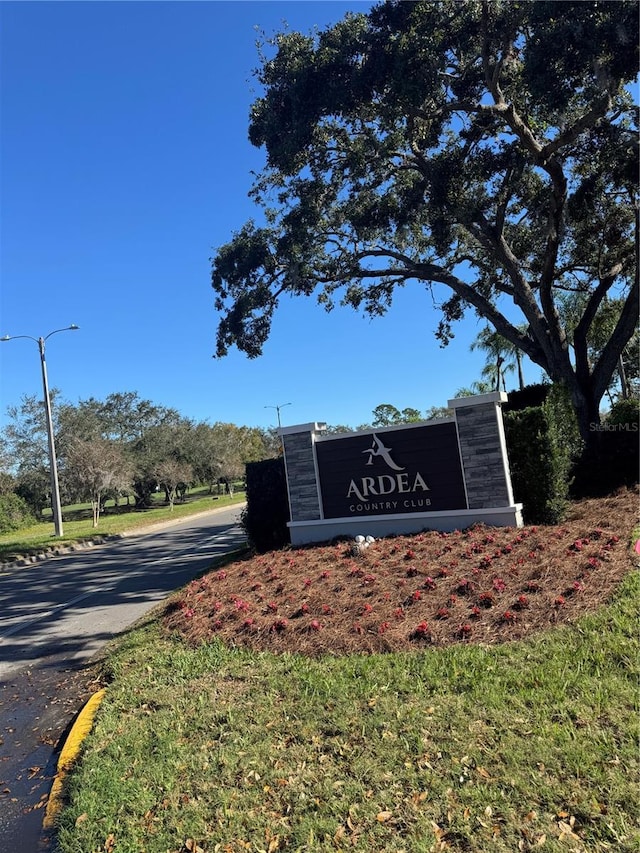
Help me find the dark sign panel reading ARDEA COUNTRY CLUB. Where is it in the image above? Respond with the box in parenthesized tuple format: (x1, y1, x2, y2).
(315, 423, 467, 518)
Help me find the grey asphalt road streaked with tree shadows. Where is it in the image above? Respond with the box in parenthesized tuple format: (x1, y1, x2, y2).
(0, 505, 244, 853)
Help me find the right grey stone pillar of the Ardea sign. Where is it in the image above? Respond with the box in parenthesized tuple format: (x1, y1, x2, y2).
(449, 392, 513, 509)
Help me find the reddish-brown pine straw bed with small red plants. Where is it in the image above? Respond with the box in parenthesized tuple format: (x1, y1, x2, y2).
(163, 490, 639, 656)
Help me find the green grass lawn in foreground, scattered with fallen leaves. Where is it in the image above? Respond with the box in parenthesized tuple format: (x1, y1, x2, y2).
(58, 560, 640, 853)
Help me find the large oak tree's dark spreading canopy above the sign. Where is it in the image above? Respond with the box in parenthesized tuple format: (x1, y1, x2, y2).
(212, 0, 638, 446)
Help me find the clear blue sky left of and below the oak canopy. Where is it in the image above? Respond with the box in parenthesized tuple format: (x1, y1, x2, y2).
(0, 0, 538, 427)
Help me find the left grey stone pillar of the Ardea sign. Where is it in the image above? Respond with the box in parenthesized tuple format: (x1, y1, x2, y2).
(281, 424, 322, 521)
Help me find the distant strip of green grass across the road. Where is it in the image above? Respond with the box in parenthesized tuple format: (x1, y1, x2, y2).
(0, 488, 245, 563)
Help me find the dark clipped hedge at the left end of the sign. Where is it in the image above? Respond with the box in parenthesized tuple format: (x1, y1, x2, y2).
(242, 457, 291, 551)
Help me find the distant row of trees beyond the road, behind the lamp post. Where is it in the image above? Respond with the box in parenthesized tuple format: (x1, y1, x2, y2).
(0, 390, 279, 525)
